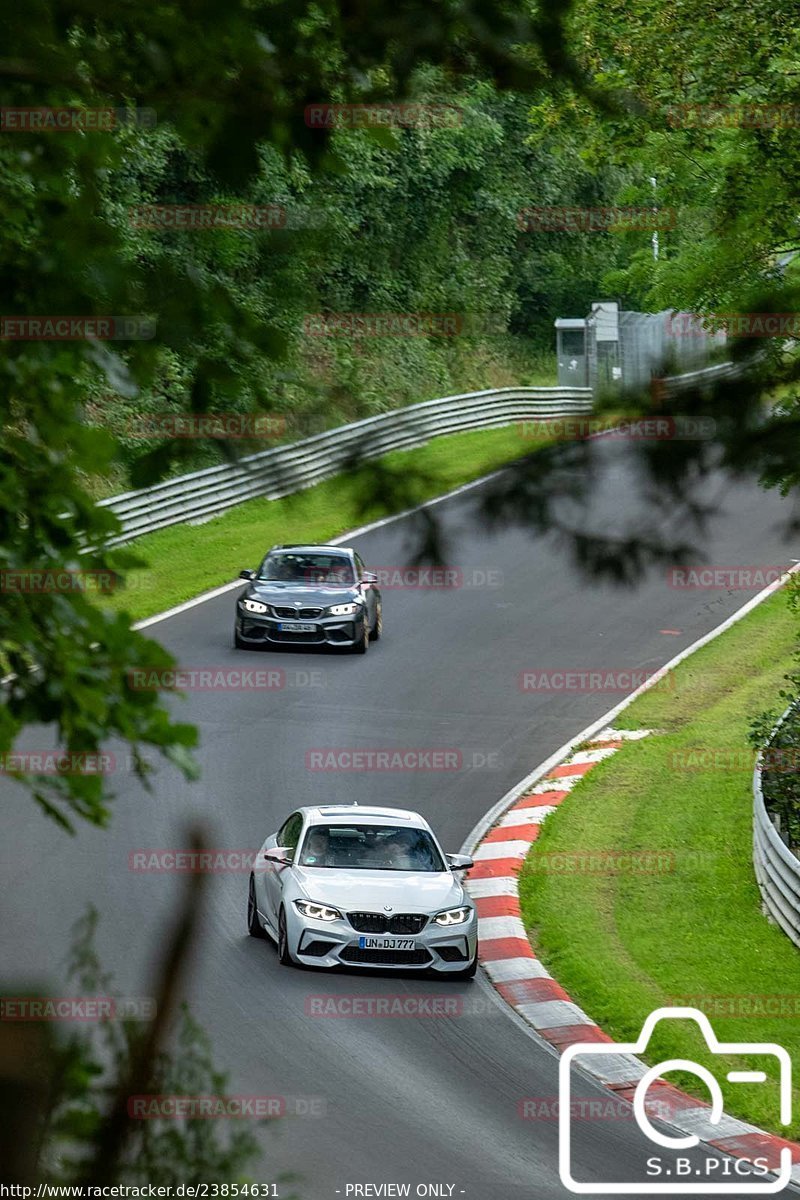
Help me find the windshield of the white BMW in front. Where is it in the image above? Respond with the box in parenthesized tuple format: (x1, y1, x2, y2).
(297, 824, 446, 871)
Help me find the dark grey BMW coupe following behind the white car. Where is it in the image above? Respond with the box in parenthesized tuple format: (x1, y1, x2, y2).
(234, 545, 383, 654)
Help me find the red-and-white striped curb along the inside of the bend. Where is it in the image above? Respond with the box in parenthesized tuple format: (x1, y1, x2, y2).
(465, 727, 800, 1183)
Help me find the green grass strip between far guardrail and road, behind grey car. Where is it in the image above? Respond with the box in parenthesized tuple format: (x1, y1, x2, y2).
(107, 425, 563, 620)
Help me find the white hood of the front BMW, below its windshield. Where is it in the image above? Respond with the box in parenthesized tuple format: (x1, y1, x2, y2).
(294, 866, 465, 913)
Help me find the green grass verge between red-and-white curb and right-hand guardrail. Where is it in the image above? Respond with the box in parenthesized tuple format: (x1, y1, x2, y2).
(519, 592, 800, 1138)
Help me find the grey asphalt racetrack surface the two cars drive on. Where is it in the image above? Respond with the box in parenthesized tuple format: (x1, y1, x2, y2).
(0, 442, 796, 1200)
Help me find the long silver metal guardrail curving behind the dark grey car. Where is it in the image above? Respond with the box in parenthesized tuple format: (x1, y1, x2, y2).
(100, 388, 591, 545)
